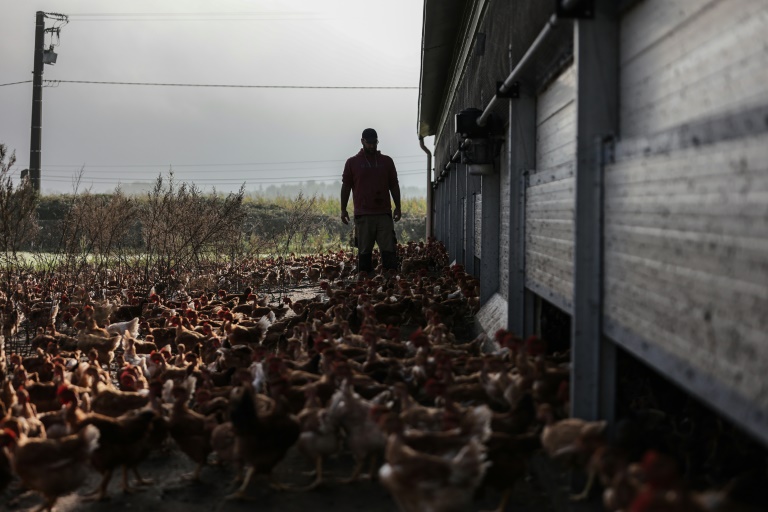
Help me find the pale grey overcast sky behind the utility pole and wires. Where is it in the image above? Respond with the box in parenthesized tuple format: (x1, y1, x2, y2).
(0, 0, 431, 194)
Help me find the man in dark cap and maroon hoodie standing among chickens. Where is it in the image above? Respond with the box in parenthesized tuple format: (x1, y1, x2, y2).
(341, 128, 400, 273)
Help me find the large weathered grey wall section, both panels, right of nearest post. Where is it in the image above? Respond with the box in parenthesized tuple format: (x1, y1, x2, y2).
(605, 0, 768, 428)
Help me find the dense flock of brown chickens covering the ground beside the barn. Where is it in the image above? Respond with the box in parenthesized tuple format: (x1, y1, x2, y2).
(0, 241, 764, 511)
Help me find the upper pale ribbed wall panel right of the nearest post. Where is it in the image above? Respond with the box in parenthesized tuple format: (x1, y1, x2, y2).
(620, 0, 768, 139)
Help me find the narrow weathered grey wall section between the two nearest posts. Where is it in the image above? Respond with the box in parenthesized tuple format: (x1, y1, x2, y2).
(525, 66, 576, 312)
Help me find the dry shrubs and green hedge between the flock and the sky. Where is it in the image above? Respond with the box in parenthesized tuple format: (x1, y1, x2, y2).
(0, 144, 426, 290)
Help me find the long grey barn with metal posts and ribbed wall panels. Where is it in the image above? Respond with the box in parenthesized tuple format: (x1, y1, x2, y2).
(418, 0, 768, 445)
